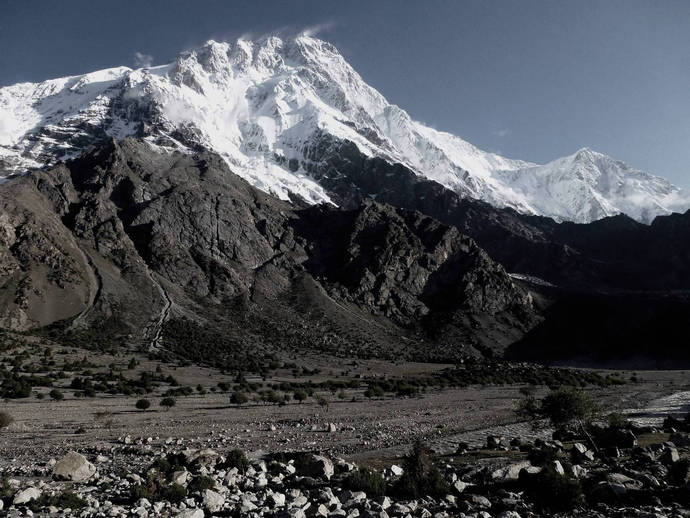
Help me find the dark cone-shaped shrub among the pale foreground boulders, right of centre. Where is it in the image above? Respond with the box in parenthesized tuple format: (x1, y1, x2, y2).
(393, 440, 450, 499)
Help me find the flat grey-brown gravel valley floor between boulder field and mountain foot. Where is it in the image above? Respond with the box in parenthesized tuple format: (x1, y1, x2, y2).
(0, 351, 690, 469)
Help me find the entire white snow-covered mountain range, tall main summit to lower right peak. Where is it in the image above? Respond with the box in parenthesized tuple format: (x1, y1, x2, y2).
(0, 36, 690, 222)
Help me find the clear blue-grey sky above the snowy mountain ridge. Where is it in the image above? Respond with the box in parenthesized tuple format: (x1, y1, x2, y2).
(0, 0, 690, 187)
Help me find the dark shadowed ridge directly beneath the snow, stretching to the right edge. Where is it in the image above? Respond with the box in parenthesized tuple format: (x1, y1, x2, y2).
(306, 138, 690, 292)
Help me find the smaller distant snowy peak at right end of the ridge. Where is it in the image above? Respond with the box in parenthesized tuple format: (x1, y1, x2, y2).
(499, 148, 690, 223)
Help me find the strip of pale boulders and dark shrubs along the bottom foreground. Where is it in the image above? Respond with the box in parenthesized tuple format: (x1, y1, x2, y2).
(0, 417, 690, 518)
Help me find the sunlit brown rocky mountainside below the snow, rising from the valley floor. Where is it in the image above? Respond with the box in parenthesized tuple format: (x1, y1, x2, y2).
(0, 139, 537, 364)
